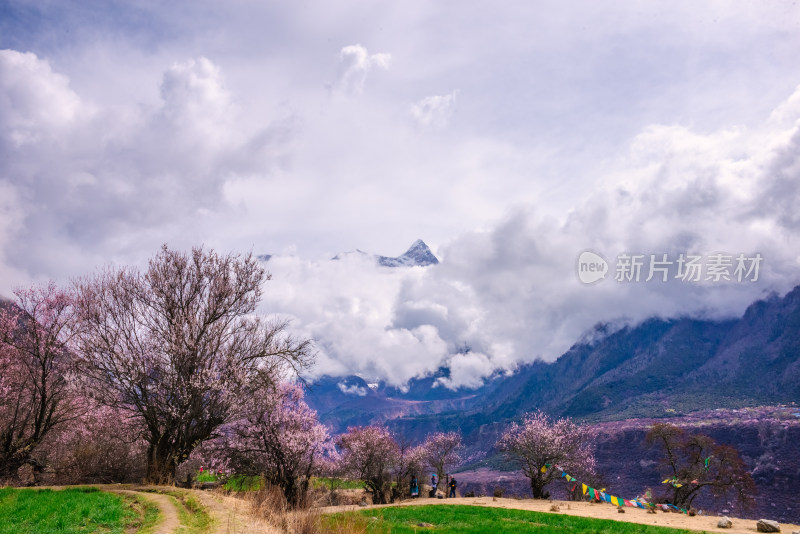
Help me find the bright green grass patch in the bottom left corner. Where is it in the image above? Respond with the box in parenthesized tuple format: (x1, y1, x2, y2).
(0, 488, 158, 534)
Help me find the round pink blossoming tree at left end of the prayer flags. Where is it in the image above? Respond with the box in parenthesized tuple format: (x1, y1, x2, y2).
(497, 411, 596, 499)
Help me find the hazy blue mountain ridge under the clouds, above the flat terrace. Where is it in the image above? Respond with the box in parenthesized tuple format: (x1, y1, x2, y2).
(308, 286, 800, 437)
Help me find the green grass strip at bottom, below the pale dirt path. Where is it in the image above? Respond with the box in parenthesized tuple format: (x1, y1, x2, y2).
(323, 505, 690, 534)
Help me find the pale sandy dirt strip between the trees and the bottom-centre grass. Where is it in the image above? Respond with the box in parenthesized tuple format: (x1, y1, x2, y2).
(320, 497, 800, 534)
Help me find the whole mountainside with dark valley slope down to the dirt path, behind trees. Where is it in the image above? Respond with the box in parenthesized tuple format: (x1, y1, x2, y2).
(306, 286, 800, 522)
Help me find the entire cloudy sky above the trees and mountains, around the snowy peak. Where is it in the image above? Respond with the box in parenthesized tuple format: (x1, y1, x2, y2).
(0, 0, 800, 387)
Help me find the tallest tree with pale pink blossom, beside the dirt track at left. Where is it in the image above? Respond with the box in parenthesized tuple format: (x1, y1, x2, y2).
(75, 245, 312, 482)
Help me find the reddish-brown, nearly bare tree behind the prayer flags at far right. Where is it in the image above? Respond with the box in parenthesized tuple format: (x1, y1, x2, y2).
(645, 423, 756, 508)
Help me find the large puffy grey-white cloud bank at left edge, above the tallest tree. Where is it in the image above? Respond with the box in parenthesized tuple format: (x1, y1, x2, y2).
(0, 50, 292, 284)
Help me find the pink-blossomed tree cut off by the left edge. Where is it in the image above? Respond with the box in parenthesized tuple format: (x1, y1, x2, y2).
(0, 283, 76, 486)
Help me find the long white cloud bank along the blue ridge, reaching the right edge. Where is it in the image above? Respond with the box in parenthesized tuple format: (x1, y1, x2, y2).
(270, 87, 800, 387)
